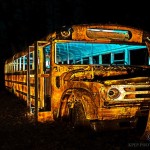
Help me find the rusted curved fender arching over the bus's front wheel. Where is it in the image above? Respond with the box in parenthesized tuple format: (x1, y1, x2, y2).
(59, 88, 97, 120)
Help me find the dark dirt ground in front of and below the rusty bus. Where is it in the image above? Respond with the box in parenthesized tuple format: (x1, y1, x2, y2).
(0, 90, 150, 150)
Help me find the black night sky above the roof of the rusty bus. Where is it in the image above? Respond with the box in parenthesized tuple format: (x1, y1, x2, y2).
(0, 0, 150, 88)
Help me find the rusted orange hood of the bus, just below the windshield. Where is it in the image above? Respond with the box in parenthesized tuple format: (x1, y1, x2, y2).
(64, 65, 150, 83)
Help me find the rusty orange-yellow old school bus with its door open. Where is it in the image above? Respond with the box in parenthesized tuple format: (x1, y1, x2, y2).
(5, 24, 150, 139)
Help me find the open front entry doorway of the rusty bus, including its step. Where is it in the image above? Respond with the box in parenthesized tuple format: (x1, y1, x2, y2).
(35, 41, 52, 122)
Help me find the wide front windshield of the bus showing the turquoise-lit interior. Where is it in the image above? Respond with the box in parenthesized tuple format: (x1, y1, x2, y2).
(55, 41, 149, 65)
